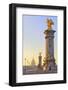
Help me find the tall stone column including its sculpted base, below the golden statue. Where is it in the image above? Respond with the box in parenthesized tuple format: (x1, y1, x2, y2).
(44, 30, 57, 72)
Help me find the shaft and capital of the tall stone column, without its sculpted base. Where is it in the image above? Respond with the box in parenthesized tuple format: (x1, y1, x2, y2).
(44, 30, 55, 60)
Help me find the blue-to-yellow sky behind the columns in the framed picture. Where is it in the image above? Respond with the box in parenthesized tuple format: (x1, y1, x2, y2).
(22, 15, 57, 65)
